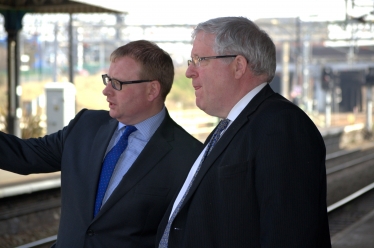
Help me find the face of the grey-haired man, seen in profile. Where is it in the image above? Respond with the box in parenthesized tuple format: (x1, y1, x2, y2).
(186, 32, 234, 118)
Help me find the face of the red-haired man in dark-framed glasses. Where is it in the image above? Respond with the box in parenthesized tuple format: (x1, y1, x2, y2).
(103, 57, 151, 125)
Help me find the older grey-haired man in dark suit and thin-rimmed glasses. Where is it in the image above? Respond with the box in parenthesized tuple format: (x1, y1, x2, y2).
(156, 17, 331, 248)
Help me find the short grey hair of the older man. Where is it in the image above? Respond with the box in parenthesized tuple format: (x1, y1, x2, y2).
(192, 17, 276, 83)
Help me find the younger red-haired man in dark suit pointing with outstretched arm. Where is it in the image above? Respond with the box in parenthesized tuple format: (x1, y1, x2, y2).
(0, 41, 203, 248)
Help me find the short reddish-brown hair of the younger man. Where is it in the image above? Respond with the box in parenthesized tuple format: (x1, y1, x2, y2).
(110, 40, 174, 100)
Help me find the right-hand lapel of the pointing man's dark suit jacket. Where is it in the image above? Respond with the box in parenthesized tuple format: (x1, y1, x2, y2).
(97, 113, 174, 217)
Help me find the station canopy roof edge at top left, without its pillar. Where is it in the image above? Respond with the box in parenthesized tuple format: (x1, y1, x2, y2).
(0, 0, 124, 14)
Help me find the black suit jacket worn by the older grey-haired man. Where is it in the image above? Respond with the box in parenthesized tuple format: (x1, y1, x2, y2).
(156, 85, 331, 248)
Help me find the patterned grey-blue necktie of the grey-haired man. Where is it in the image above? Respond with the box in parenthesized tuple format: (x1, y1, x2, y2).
(158, 119, 230, 248)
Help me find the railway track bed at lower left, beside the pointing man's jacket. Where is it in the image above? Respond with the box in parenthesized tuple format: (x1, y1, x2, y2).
(0, 188, 60, 248)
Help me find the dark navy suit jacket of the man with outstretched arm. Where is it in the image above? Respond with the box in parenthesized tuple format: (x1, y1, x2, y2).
(0, 110, 203, 248)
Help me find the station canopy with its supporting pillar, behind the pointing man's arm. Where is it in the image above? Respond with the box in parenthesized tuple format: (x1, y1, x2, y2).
(0, 0, 126, 137)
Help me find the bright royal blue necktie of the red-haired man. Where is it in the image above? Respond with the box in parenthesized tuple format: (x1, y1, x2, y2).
(94, 126, 136, 217)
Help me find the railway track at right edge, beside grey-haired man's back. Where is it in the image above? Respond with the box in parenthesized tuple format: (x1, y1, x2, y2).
(326, 143, 374, 244)
